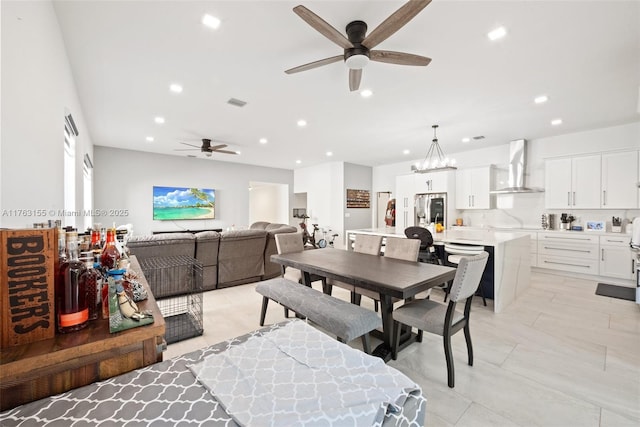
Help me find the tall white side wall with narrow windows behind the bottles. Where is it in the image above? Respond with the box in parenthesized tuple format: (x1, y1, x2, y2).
(0, 1, 93, 228)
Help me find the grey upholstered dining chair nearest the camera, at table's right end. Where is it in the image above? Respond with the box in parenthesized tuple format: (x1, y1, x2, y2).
(391, 252, 489, 388)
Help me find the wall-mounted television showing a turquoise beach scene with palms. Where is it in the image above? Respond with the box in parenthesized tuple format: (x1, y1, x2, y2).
(153, 187, 216, 221)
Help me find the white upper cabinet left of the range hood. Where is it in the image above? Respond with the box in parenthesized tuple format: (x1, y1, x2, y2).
(456, 166, 494, 209)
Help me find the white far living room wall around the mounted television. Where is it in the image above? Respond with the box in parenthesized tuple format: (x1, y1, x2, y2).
(94, 146, 293, 234)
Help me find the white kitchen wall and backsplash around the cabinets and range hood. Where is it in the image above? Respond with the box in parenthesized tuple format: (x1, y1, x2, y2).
(373, 122, 640, 228)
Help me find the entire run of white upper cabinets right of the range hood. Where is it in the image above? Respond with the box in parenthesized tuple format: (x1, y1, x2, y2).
(544, 151, 639, 209)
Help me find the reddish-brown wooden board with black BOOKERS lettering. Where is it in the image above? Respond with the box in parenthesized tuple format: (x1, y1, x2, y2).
(0, 229, 57, 348)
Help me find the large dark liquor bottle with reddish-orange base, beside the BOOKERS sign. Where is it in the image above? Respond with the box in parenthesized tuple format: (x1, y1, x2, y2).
(55, 232, 89, 333)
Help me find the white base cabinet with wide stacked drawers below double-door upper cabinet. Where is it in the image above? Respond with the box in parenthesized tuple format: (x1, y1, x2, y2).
(538, 231, 600, 275)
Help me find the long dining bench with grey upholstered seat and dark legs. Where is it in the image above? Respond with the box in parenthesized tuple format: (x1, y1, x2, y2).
(256, 277, 382, 353)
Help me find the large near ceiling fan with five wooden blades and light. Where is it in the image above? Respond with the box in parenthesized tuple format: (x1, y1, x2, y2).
(285, 0, 431, 92)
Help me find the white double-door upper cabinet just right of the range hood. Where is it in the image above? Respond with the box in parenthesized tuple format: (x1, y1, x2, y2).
(544, 154, 601, 209)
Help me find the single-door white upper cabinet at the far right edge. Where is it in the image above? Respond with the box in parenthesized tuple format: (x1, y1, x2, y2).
(601, 151, 639, 209)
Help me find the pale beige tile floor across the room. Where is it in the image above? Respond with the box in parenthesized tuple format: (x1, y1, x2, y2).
(164, 272, 640, 427)
